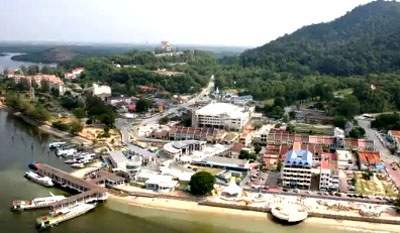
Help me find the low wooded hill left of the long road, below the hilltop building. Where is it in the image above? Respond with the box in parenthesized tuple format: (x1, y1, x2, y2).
(59, 50, 218, 95)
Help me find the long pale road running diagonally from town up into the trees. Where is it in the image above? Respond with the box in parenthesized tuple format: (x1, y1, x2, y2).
(115, 75, 214, 144)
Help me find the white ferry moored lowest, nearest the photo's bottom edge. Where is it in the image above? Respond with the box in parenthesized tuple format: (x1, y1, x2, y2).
(36, 204, 96, 230)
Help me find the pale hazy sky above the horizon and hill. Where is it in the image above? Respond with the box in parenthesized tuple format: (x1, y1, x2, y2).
(0, 0, 372, 46)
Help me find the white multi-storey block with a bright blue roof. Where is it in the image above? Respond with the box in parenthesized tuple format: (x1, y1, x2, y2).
(282, 150, 313, 189)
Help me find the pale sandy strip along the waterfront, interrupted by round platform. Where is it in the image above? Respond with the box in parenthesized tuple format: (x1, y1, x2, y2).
(109, 194, 400, 233)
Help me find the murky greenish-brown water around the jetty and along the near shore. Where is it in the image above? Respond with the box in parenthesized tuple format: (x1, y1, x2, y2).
(0, 110, 351, 233)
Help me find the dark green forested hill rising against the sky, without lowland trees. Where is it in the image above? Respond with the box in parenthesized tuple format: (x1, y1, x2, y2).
(240, 0, 400, 76)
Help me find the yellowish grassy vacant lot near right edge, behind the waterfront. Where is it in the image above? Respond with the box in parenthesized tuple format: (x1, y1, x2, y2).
(355, 173, 397, 197)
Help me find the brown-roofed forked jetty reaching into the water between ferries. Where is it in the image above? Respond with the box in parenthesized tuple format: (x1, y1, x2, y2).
(35, 163, 123, 211)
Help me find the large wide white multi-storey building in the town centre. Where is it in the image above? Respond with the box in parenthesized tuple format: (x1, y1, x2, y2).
(192, 103, 254, 131)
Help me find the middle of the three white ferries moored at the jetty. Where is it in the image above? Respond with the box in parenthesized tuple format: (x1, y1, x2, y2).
(11, 193, 66, 211)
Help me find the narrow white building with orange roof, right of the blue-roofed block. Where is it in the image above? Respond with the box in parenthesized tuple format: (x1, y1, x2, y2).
(319, 153, 339, 191)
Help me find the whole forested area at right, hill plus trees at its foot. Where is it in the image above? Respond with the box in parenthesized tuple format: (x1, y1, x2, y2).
(212, 0, 400, 117)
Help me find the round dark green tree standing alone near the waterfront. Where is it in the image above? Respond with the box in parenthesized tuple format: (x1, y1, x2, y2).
(189, 171, 215, 196)
